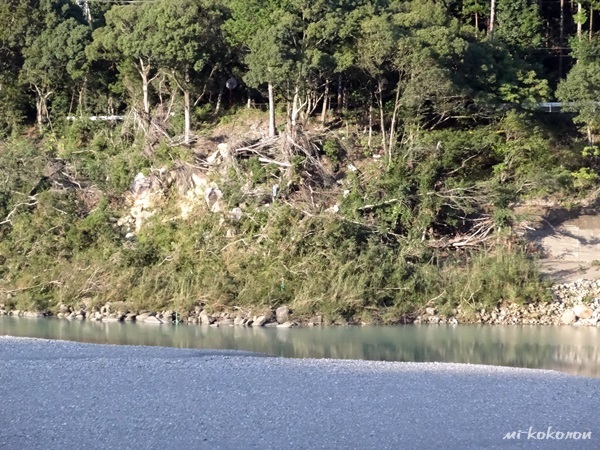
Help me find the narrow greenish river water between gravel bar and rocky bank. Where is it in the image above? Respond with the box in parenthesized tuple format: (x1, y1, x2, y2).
(0, 317, 600, 377)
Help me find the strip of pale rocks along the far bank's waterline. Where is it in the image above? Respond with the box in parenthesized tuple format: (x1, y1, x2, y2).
(0, 279, 600, 328)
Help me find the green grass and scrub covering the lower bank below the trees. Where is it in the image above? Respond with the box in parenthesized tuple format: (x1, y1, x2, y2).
(0, 110, 581, 323)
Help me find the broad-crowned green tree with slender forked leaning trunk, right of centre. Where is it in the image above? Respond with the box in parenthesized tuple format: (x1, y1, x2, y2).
(356, 0, 467, 163)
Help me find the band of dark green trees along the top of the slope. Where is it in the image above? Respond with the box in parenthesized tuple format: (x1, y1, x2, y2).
(0, 0, 598, 144)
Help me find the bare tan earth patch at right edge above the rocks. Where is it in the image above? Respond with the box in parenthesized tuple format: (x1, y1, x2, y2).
(526, 210, 600, 283)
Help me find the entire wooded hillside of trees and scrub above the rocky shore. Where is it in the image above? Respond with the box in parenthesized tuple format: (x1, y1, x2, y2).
(0, 0, 600, 323)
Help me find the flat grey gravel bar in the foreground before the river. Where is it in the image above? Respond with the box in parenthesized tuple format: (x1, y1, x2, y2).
(0, 337, 600, 450)
